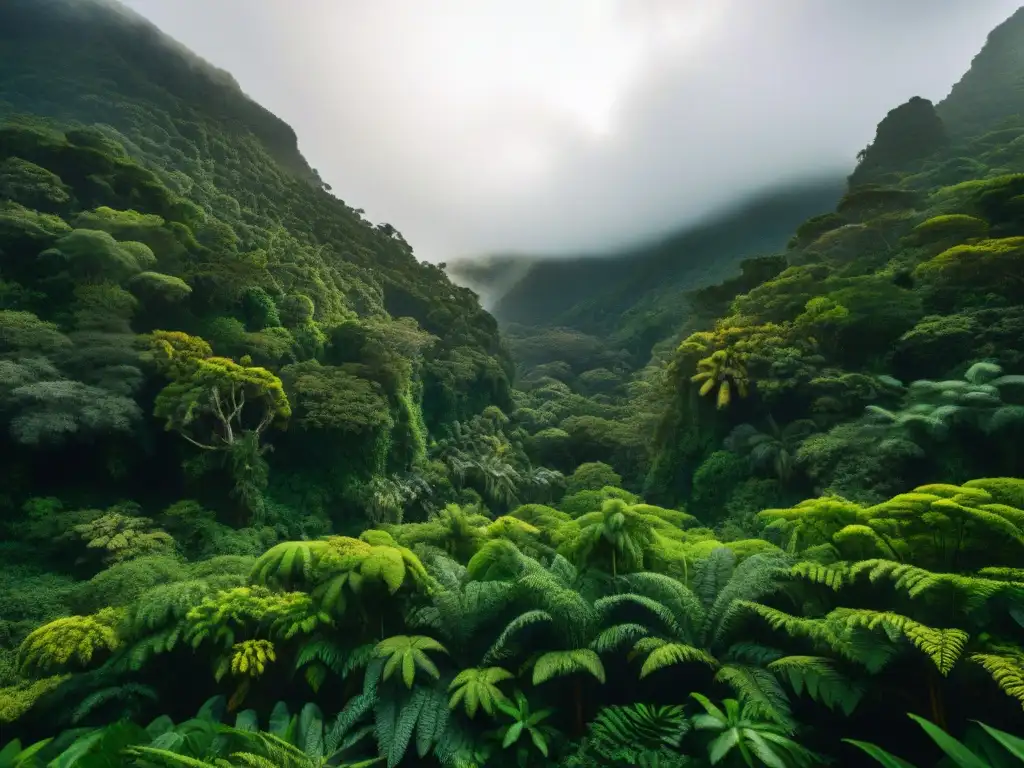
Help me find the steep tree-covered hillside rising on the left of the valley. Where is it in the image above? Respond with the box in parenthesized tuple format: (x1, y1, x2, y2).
(0, 0, 520, 527)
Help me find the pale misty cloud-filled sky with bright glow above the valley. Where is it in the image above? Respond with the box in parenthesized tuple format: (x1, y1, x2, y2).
(124, 0, 1020, 261)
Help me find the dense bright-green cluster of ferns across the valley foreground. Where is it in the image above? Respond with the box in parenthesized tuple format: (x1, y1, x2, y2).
(3, 478, 1024, 768)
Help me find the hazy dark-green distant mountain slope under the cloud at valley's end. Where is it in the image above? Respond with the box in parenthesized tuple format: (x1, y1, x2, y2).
(449, 178, 846, 354)
